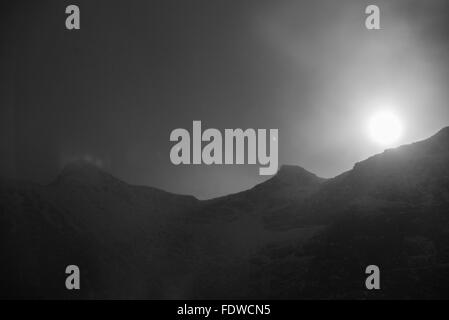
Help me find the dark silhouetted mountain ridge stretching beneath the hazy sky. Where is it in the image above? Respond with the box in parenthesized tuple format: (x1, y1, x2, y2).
(0, 128, 449, 299)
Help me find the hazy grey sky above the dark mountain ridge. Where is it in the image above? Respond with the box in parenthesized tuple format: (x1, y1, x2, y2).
(0, 0, 449, 199)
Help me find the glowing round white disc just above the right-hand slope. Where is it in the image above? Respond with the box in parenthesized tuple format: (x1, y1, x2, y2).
(369, 111, 403, 146)
